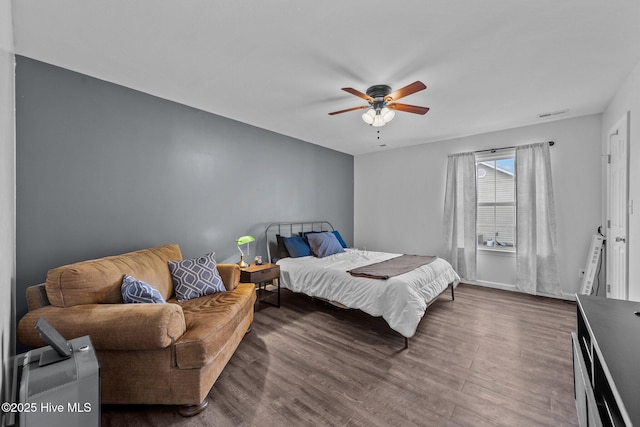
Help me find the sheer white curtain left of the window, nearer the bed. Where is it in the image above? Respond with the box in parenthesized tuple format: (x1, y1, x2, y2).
(443, 153, 477, 280)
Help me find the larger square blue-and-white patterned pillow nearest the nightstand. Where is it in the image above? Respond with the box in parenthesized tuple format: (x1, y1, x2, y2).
(169, 252, 227, 302)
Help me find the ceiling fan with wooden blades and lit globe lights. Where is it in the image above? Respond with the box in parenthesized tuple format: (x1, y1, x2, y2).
(329, 81, 429, 126)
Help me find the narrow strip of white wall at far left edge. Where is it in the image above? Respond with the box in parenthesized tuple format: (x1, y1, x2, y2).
(0, 1, 16, 416)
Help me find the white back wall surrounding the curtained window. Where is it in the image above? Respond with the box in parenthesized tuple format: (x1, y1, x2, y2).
(354, 114, 603, 298)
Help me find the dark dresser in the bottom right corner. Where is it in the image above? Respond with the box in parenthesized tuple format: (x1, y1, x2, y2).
(571, 295, 640, 426)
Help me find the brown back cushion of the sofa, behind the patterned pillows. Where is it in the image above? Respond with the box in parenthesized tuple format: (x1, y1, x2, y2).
(45, 244, 182, 307)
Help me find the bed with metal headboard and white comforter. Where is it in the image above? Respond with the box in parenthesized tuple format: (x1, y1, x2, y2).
(265, 221, 460, 348)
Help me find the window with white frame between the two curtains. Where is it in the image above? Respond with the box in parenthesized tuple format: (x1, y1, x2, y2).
(476, 150, 516, 252)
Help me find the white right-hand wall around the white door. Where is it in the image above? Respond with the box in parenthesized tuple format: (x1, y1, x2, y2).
(602, 62, 640, 301)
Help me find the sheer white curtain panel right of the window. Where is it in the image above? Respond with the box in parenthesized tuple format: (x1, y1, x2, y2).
(516, 142, 562, 295)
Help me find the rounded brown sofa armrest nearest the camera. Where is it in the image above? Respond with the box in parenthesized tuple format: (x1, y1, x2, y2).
(17, 304, 186, 350)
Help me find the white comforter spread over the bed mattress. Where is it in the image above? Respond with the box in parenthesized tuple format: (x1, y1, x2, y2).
(277, 249, 460, 338)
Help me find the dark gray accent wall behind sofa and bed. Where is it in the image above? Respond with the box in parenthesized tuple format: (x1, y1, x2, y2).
(16, 56, 353, 324)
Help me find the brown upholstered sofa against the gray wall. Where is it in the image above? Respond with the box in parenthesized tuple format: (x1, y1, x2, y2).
(18, 244, 256, 415)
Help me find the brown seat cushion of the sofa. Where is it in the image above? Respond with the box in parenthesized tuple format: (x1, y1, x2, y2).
(175, 283, 256, 369)
